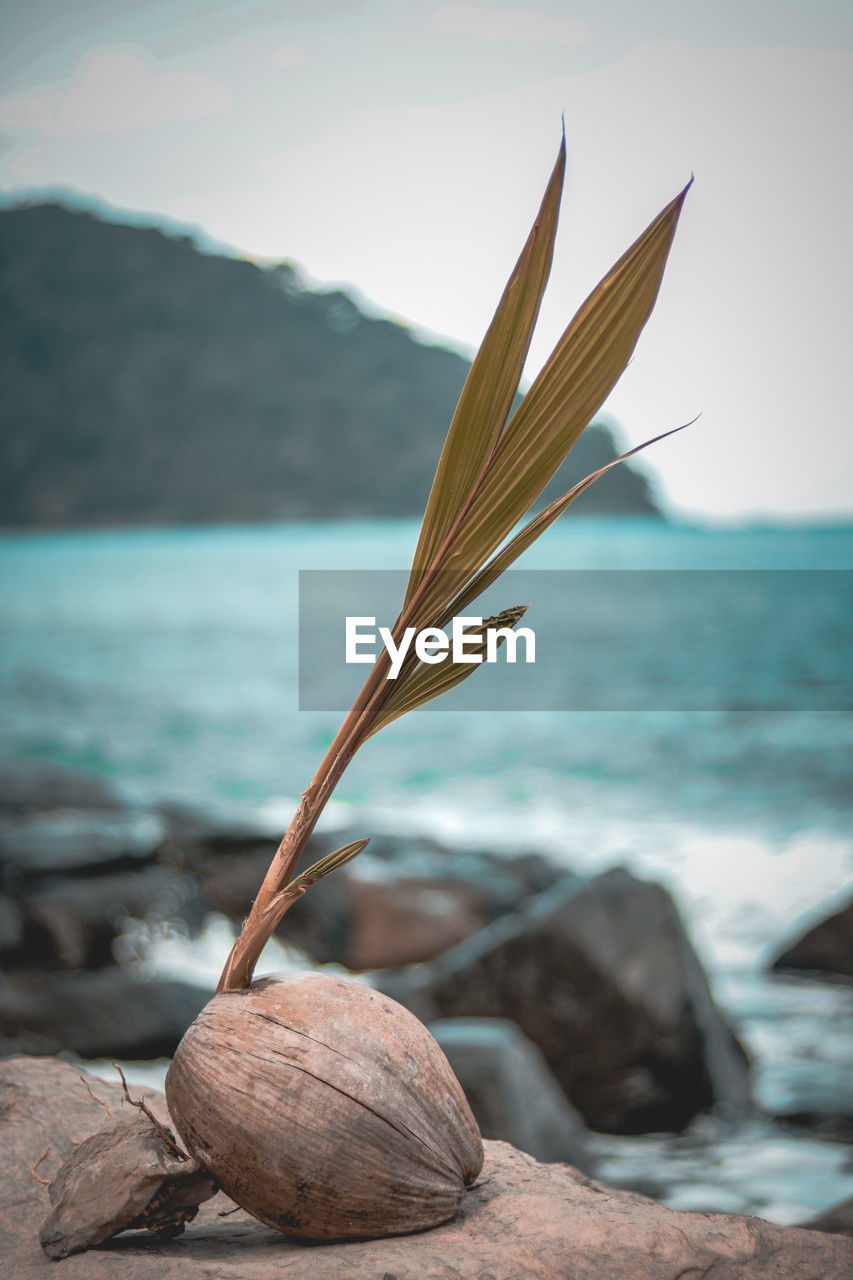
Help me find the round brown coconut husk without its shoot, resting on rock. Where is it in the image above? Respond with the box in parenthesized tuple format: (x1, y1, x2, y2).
(165, 973, 483, 1240)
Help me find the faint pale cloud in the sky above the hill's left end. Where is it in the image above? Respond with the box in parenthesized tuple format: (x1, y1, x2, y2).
(0, 45, 231, 134)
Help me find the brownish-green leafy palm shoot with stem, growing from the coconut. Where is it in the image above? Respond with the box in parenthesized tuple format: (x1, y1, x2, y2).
(216, 138, 693, 991)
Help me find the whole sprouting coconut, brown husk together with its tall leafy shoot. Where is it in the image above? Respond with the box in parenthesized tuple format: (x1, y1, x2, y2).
(41, 138, 689, 1240)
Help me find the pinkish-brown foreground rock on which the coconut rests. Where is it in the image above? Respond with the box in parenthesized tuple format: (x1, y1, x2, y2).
(0, 1059, 853, 1280)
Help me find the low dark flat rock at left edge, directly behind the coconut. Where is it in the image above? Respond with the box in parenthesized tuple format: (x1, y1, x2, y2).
(0, 968, 213, 1059)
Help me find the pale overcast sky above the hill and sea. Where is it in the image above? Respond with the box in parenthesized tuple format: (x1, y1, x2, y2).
(0, 0, 853, 522)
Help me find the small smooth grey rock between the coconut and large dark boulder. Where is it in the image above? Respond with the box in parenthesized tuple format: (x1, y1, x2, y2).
(429, 1018, 593, 1174)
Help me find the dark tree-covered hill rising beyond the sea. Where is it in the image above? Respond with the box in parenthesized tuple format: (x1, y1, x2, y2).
(0, 204, 658, 527)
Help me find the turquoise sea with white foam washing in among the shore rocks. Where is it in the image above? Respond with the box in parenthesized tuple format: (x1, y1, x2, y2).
(0, 517, 853, 1222)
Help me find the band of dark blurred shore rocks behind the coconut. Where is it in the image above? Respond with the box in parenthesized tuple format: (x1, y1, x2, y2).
(0, 762, 849, 1249)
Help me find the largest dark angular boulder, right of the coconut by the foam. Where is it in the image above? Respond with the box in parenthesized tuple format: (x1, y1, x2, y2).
(373, 869, 749, 1133)
